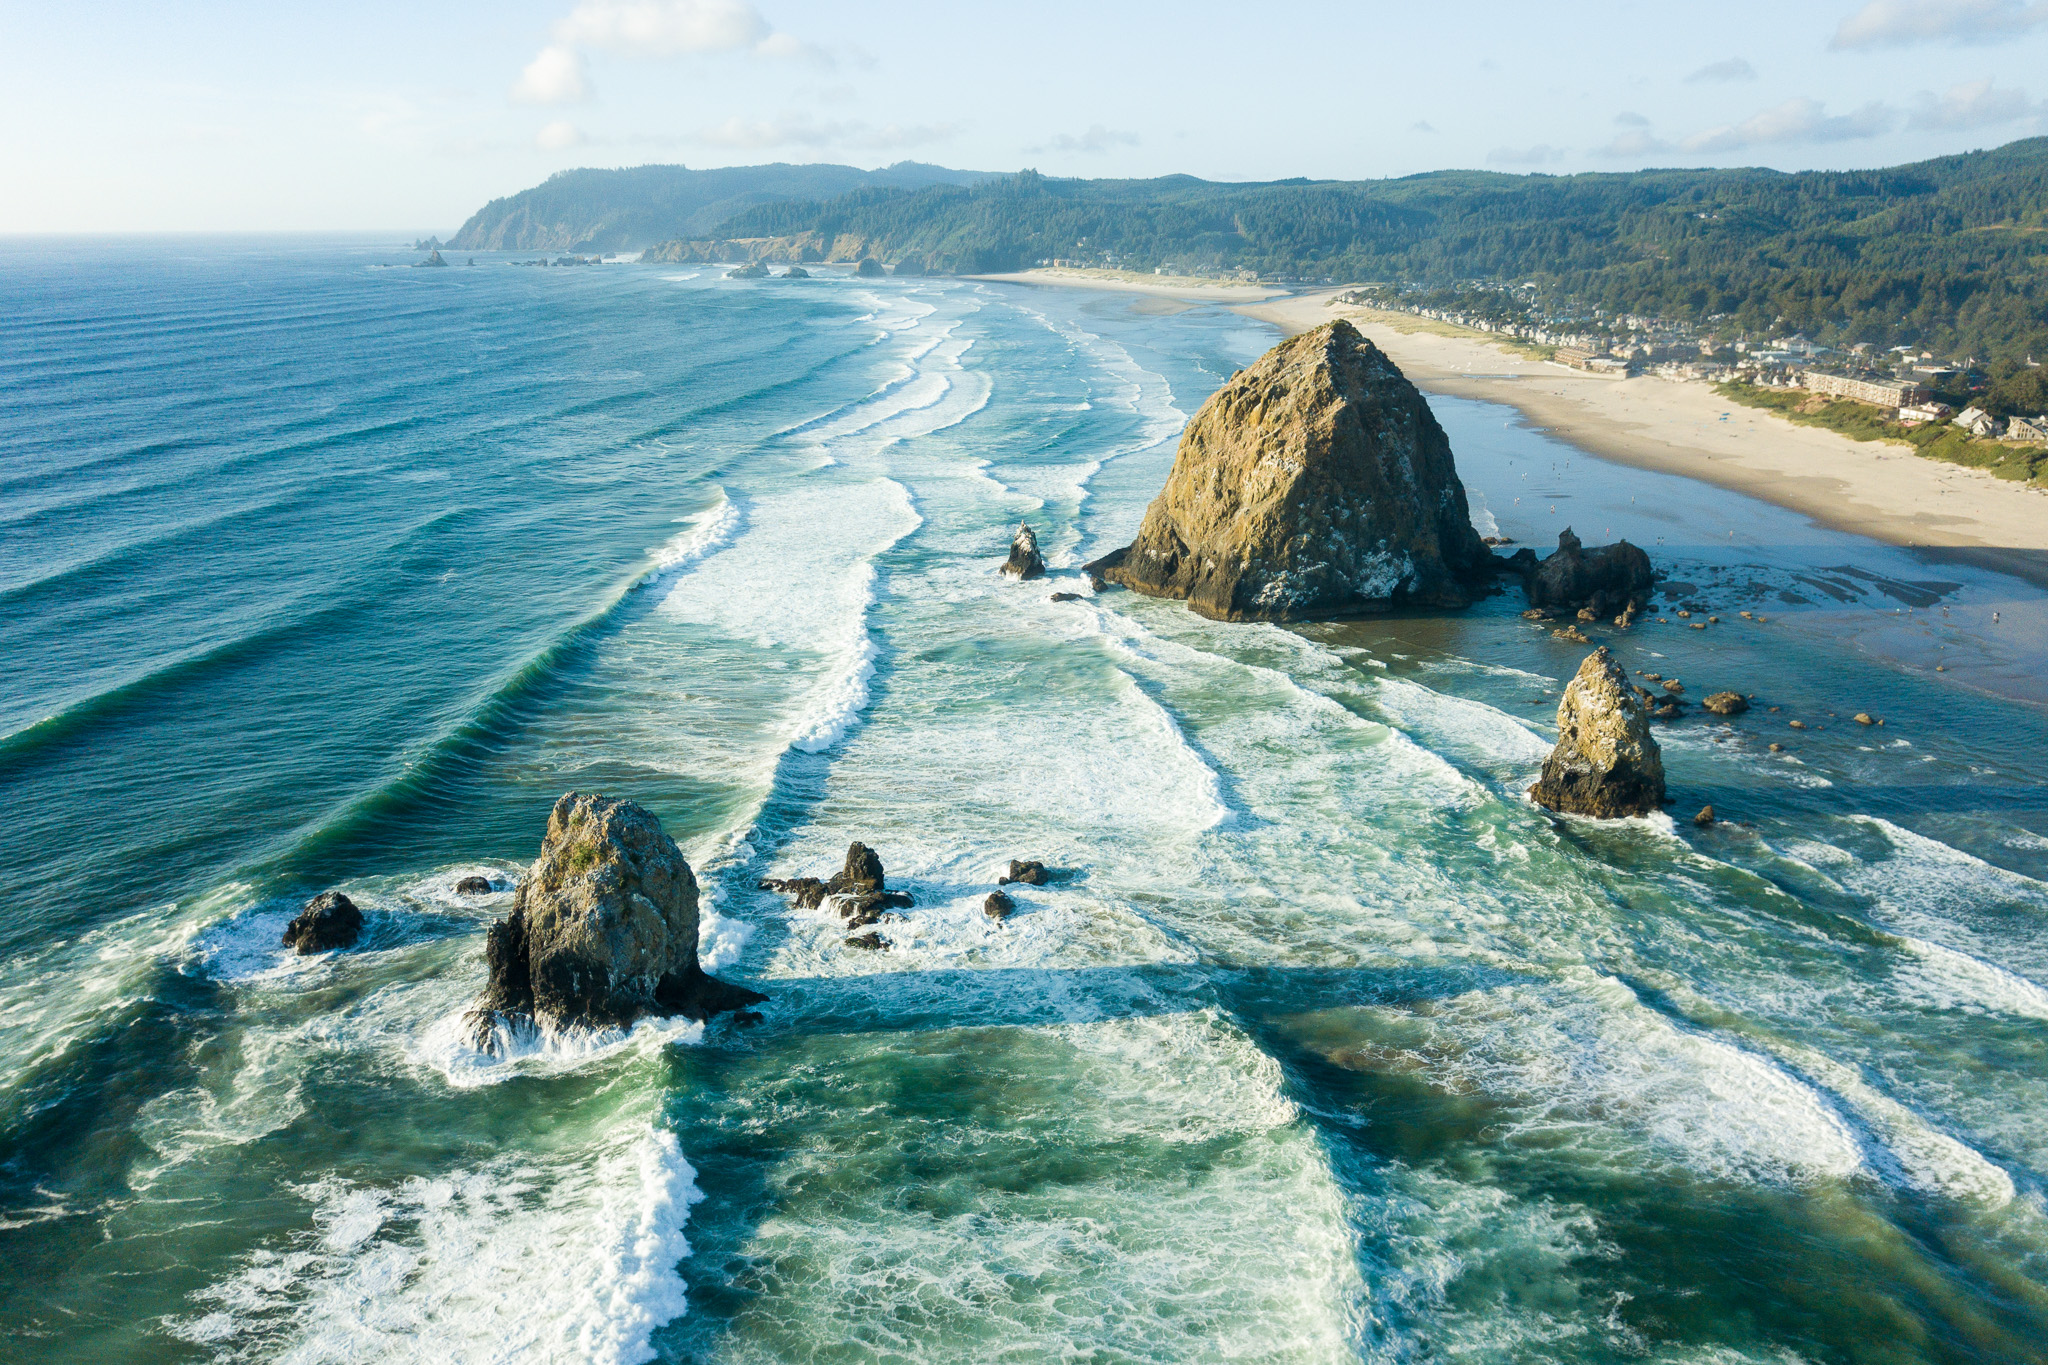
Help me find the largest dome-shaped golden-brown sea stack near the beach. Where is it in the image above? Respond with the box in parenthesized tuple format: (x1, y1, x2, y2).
(1087, 321, 1493, 620)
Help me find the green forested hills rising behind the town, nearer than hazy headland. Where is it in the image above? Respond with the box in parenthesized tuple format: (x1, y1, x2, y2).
(700, 139, 2048, 366)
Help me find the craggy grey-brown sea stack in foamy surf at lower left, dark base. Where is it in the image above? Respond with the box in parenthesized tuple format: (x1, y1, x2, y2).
(469, 792, 766, 1048)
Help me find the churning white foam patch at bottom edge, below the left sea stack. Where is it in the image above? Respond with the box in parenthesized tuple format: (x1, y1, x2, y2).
(170, 1119, 702, 1365)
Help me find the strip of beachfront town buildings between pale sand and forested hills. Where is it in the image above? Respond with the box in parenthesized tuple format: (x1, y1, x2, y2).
(1333, 284, 2048, 444)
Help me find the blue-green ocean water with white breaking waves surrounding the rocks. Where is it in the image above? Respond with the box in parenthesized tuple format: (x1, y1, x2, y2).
(0, 239, 2048, 1365)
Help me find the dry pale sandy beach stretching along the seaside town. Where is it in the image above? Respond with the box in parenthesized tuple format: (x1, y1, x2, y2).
(1237, 291, 2048, 587)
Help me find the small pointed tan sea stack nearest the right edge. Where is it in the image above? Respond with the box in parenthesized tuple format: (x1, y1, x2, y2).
(1530, 649, 1665, 821)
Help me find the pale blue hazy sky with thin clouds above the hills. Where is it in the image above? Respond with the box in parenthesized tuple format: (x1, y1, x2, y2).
(0, 0, 2048, 233)
